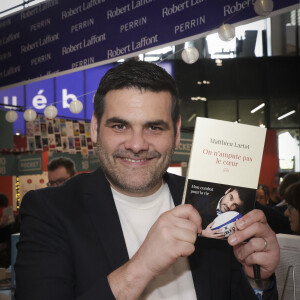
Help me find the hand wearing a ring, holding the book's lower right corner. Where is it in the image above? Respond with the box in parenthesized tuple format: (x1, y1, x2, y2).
(228, 210, 280, 286)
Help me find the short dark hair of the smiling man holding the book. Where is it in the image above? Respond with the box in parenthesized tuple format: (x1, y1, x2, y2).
(94, 59, 179, 134)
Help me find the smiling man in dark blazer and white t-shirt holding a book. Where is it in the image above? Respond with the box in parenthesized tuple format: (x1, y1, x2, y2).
(15, 60, 279, 300)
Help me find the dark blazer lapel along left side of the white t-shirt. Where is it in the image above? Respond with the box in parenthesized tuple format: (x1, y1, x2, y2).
(83, 168, 129, 271)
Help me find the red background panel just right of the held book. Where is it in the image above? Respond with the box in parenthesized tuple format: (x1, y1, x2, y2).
(258, 129, 279, 191)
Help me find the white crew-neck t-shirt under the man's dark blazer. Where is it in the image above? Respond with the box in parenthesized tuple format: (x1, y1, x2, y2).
(112, 183, 197, 300)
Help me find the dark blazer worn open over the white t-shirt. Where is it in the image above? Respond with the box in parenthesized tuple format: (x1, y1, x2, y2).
(15, 169, 277, 300)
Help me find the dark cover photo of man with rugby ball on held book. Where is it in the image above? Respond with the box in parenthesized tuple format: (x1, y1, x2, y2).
(184, 179, 256, 239)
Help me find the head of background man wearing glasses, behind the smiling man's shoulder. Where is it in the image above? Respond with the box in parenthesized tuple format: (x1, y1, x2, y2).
(47, 157, 76, 186)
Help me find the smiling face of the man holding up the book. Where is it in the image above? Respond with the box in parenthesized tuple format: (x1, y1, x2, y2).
(91, 89, 180, 196)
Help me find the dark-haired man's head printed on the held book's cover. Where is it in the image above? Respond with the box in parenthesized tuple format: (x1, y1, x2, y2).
(220, 187, 247, 213)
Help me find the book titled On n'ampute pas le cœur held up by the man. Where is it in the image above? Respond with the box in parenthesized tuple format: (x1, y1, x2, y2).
(182, 117, 266, 239)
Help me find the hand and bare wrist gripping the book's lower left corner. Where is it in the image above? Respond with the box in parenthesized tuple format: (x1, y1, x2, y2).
(108, 204, 201, 299)
